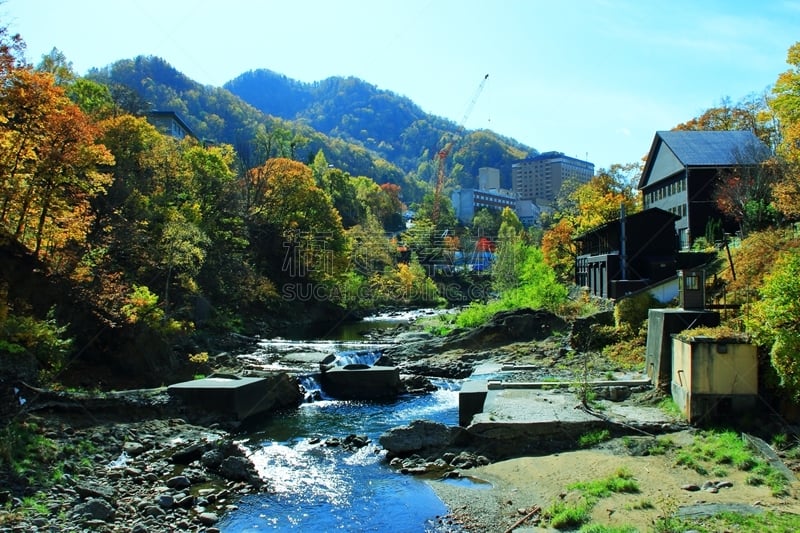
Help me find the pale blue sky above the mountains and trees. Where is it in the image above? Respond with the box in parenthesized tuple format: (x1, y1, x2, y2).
(0, 0, 800, 168)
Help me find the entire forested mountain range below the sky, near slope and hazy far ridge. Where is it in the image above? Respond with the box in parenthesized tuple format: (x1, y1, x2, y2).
(89, 56, 538, 203)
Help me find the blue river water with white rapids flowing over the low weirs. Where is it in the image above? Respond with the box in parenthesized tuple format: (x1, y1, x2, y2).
(218, 312, 460, 533)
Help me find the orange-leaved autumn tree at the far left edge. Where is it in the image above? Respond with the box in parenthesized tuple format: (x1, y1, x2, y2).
(0, 68, 113, 255)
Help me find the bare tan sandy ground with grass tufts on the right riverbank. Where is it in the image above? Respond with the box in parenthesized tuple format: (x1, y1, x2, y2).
(431, 432, 800, 532)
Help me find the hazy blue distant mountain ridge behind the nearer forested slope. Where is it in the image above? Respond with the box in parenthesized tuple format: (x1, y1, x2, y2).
(225, 69, 537, 188)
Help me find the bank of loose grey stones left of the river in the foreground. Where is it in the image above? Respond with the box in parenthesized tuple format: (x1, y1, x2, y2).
(0, 414, 269, 533)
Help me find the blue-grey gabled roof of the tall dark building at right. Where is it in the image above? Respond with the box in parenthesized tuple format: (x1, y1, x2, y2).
(639, 130, 768, 189)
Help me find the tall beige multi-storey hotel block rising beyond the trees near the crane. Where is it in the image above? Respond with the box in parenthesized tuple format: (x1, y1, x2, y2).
(511, 152, 594, 206)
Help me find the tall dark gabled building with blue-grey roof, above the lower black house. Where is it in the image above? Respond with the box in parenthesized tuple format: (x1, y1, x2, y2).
(639, 131, 768, 249)
